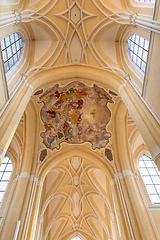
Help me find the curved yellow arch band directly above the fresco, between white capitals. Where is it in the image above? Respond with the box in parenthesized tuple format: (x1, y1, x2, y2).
(28, 64, 124, 91)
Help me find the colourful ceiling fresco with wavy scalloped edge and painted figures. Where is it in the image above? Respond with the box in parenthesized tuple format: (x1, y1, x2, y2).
(38, 82, 114, 149)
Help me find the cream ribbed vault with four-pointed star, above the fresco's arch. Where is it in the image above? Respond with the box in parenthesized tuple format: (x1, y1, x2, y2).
(22, 0, 129, 71)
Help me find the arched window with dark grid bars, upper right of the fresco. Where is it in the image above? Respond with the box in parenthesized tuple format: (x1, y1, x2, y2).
(127, 34, 149, 74)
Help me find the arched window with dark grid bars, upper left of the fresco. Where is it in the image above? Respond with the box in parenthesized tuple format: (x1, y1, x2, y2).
(1, 32, 23, 73)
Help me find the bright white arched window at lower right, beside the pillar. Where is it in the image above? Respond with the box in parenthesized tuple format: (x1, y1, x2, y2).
(139, 155, 160, 203)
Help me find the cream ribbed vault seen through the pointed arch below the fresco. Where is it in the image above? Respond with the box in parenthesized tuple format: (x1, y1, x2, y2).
(40, 157, 113, 240)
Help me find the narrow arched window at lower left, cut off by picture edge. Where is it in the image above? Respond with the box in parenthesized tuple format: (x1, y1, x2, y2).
(0, 156, 12, 204)
